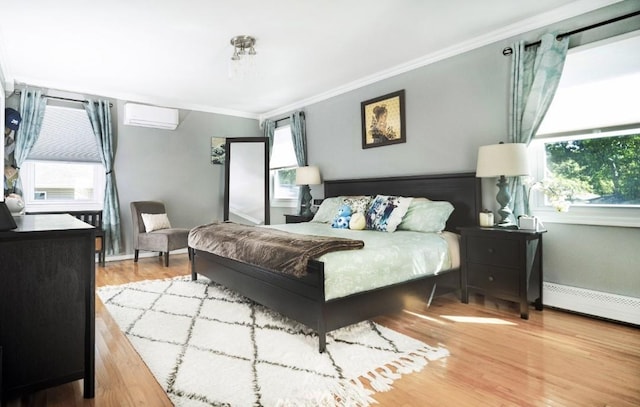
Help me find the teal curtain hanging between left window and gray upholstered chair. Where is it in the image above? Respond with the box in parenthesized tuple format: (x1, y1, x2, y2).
(84, 100, 122, 254)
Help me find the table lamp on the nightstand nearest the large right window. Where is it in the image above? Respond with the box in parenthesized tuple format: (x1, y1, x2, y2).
(476, 142, 529, 227)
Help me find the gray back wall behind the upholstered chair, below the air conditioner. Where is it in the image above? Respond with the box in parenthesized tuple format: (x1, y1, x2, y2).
(114, 101, 262, 254)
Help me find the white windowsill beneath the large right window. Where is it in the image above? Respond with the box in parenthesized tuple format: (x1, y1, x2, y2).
(532, 206, 640, 228)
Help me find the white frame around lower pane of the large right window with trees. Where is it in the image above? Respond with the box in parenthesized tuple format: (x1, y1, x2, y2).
(529, 127, 640, 227)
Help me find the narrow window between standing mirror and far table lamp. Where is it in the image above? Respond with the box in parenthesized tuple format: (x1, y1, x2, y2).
(269, 125, 300, 207)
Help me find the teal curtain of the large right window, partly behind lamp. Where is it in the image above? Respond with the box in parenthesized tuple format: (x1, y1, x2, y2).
(509, 33, 569, 218)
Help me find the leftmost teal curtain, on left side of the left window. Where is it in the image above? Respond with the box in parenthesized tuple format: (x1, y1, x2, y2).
(14, 89, 47, 196)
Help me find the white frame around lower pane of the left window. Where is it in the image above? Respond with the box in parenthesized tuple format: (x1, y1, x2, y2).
(20, 160, 106, 213)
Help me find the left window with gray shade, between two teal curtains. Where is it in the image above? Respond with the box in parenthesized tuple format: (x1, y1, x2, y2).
(20, 106, 105, 212)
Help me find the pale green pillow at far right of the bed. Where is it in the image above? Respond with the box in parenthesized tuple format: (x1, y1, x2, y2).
(398, 199, 454, 233)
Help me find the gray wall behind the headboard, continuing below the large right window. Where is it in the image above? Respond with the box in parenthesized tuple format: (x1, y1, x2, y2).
(305, 1, 640, 297)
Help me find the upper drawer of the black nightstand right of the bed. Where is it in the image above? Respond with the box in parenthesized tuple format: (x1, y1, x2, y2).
(467, 236, 519, 267)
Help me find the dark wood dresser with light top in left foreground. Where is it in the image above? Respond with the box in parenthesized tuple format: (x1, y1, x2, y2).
(0, 215, 95, 399)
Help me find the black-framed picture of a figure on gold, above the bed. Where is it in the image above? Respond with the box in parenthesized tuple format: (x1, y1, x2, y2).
(361, 89, 407, 148)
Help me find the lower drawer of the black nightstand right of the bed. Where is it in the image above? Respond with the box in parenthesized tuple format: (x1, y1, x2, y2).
(467, 263, 520, 297)
